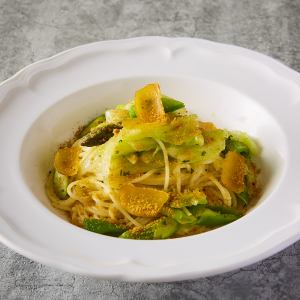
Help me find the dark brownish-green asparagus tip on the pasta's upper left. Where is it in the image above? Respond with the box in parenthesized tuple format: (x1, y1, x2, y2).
(81, 124, 122, 147)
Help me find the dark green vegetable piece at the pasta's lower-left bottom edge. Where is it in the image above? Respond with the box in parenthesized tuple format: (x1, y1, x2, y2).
(83, 219, 128, 236)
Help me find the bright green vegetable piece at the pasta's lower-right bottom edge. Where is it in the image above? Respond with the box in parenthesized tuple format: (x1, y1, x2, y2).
(196, 208, 239, 227)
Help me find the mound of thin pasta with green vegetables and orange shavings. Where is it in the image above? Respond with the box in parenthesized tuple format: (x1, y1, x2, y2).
(46, 83, 260, 240)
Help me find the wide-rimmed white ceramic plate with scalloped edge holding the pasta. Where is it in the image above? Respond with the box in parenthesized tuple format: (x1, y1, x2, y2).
(0, 37, 300, 281)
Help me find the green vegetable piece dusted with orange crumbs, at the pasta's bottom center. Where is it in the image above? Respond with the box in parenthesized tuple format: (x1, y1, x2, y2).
(120, 217, 178, 240)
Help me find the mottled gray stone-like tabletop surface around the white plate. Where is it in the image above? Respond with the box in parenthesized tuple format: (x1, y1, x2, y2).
(0, 0, 300, 299)
